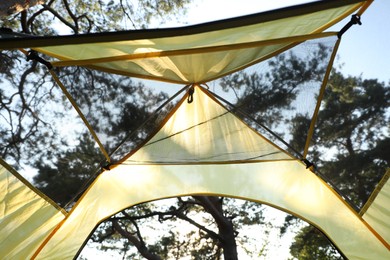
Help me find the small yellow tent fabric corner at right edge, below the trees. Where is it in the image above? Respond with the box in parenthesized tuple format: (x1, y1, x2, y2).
(363, 169, 390, 243)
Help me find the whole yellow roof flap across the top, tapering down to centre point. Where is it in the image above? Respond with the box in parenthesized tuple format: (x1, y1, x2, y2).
(0, 0, 366, 84)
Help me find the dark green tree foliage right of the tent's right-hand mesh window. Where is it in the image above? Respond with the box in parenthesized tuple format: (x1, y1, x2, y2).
(314, 71, 390, 208)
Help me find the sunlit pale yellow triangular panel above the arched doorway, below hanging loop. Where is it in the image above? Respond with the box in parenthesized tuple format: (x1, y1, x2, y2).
(124, 87, 294, 164)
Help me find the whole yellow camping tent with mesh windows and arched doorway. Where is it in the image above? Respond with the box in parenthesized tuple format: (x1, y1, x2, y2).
(0, 0, 390, 259)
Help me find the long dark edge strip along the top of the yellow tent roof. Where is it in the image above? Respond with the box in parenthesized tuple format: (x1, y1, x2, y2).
(0, 0, 366, 49)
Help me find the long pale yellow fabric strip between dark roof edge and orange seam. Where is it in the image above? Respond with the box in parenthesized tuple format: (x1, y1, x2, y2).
(37, 4, 360, 60)
